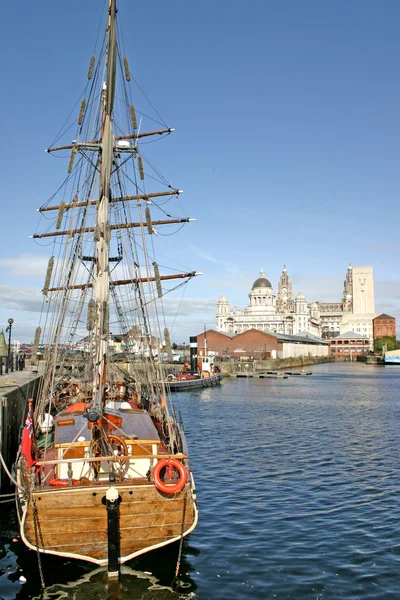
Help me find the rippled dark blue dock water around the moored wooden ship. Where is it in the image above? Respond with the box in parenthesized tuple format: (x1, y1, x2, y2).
(0, 364, 400, 600)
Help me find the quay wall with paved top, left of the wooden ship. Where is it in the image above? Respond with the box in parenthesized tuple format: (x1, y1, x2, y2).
(0, 367, 41, 493)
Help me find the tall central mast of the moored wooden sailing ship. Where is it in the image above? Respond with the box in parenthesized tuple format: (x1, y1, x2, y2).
(93, 0, 117, 412)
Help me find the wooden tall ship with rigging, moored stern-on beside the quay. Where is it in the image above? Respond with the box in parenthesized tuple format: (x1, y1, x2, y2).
(17, 0, 198, 574)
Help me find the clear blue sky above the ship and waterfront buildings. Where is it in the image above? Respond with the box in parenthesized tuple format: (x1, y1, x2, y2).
(0, 0, 400, 342)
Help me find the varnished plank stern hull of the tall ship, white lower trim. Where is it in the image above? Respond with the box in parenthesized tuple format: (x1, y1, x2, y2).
(18, 484, 198, 566)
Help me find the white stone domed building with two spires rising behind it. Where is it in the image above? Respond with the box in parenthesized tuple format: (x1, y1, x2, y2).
(217, 267, 320, 335)
